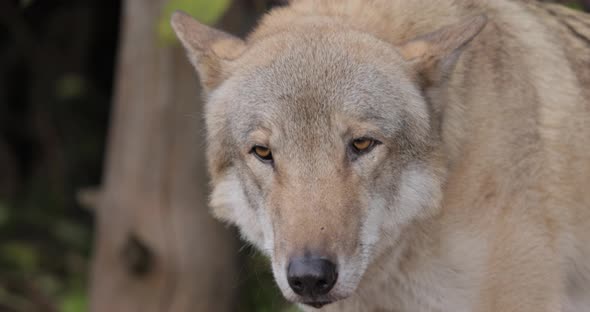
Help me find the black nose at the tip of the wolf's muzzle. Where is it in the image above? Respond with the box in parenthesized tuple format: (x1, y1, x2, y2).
(287, 257, 338, 298)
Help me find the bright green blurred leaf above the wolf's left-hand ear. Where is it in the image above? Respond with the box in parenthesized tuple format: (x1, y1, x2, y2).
(158, 0, 231, 44)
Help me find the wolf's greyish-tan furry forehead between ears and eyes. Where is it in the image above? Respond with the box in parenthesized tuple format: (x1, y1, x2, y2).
(207, 32, 429, 143)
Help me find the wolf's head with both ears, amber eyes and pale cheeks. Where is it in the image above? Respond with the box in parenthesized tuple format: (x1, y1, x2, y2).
(172, 13, 485, 307)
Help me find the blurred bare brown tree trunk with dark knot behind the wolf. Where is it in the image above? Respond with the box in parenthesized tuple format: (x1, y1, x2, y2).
(91, 0, 236, 312)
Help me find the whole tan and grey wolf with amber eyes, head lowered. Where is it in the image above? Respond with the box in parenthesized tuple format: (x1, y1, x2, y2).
(171, 0, 590, 312)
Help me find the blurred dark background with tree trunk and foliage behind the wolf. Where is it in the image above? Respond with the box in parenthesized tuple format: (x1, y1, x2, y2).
(0, 0, 590, 312)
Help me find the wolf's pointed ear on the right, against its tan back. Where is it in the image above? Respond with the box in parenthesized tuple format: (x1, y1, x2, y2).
(399, 15, 487, 88)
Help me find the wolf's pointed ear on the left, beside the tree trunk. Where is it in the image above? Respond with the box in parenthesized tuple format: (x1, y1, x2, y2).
(170, 11, 246, 91)
